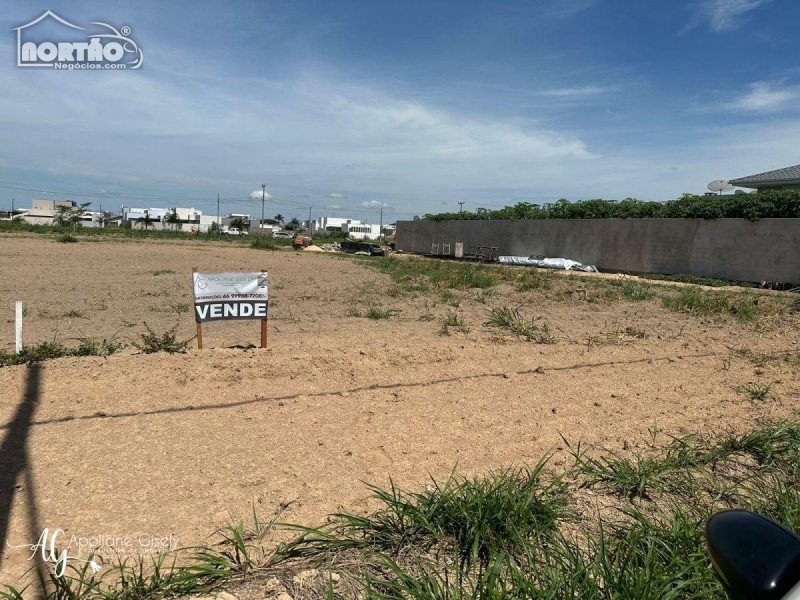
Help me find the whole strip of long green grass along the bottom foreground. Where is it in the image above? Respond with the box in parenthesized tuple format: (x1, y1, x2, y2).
(6, 420, 800, 600)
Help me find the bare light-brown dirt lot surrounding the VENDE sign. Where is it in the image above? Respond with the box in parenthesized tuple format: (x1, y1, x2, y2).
(0, 235, 800, 583)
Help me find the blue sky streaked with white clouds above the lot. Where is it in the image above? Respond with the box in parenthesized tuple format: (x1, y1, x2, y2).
(0, 0, 800, 220)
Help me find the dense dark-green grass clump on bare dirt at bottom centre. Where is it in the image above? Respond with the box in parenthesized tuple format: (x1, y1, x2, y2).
(277, 462, 570, 569)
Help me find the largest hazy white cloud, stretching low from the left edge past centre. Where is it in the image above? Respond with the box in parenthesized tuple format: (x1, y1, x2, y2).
(0, 55, 599, 211)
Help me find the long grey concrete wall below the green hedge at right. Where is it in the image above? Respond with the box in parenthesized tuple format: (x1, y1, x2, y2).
(397, 219, 800, 283)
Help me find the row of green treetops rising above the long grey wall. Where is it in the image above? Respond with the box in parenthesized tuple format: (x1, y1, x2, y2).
(414, 190, 800, 221)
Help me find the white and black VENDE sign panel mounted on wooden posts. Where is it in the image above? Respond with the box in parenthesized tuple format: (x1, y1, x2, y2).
(192, 273, 269, 323)
